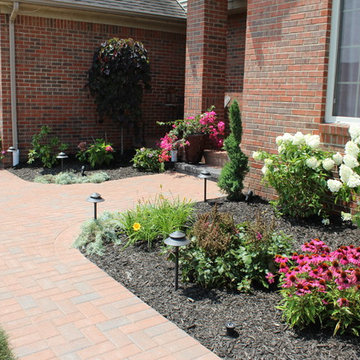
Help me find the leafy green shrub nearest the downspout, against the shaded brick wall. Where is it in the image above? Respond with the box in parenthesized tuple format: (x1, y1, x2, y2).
(28, 125, 68, 168)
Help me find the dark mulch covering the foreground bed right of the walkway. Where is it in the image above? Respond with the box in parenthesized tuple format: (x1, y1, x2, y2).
(83, 199, 360, 360)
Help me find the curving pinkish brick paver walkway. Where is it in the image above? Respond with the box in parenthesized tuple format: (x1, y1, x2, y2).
(0, 170, 219, 360)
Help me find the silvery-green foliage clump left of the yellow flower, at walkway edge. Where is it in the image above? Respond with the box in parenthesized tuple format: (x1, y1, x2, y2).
(73, 211, 123, 256)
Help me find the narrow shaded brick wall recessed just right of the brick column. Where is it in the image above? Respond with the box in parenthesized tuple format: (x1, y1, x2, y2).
(225, 12, 246, 107)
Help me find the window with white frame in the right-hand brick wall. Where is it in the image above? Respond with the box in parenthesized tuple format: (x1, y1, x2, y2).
(326, 0, 360, 123)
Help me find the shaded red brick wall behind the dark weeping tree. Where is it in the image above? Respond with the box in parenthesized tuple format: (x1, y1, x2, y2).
(0, 15, 185, 159)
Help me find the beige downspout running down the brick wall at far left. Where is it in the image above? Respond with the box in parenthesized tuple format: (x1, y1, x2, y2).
(9, 2, 19, 156)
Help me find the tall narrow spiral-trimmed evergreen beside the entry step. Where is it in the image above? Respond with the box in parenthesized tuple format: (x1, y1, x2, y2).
(218, 100, 249, 201)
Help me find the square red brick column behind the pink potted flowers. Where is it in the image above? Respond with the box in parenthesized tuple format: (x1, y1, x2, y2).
(184, 0, 228, 119)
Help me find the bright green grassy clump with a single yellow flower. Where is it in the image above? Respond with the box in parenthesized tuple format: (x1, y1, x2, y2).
(121, 194, 194, 247)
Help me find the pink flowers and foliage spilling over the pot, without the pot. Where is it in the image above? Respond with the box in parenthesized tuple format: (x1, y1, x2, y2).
(158, 107, 225, 161)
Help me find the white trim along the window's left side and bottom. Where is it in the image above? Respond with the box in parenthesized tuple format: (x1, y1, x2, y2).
(325, 0, 360, 124)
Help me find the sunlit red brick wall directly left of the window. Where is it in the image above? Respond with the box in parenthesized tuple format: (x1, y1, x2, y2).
(243, 0, 331, 197)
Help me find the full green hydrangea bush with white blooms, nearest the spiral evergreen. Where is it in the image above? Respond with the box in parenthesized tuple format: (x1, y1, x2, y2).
(253, 132, 336, 218)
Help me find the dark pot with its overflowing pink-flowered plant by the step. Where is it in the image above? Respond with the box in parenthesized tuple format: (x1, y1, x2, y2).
(158, 108, 225, 164)
